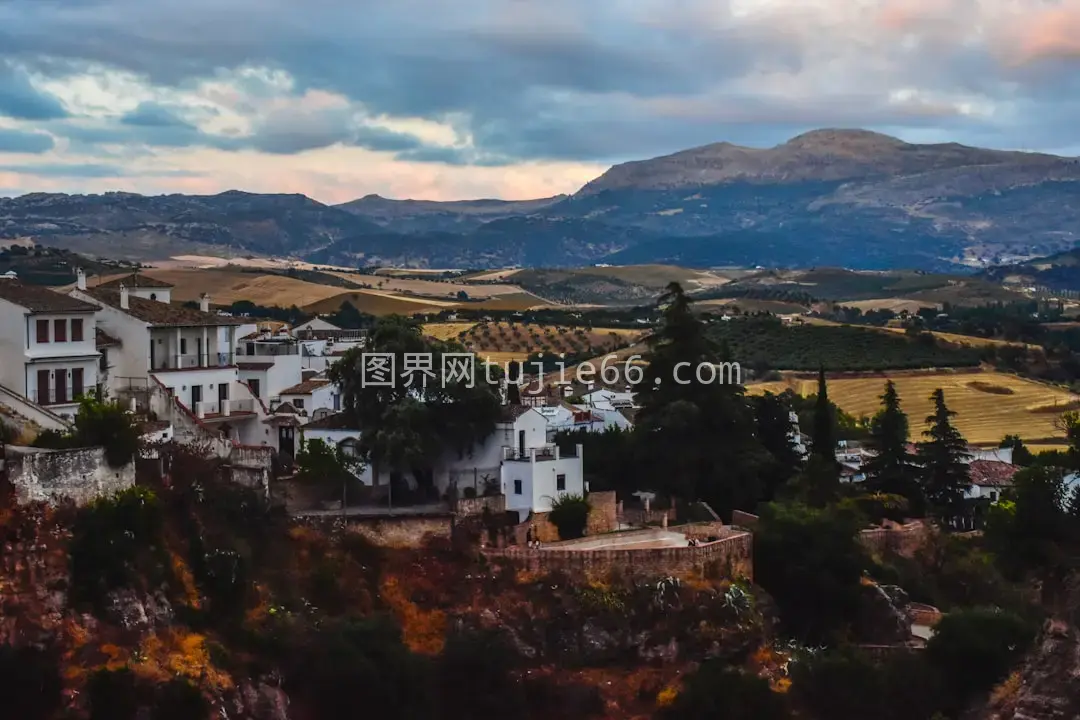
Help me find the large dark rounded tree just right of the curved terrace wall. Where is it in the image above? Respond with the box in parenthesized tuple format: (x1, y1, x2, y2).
(754, 503, 869, 642)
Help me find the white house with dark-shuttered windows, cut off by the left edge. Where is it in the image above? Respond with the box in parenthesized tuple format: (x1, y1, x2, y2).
(0, 277, 100, 419)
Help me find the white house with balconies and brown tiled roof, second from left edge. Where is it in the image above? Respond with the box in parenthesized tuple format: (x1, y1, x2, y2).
(71, 277, 278, 448)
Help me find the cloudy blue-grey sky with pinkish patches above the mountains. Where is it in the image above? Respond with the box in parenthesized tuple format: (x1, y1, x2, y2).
(0, 0, 1080, 203)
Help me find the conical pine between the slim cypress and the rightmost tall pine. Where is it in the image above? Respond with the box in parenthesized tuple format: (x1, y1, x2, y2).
(863, 380, 922, 507)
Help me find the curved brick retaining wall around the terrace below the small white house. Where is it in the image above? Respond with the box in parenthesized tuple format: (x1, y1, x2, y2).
(486, 530, 754, 580)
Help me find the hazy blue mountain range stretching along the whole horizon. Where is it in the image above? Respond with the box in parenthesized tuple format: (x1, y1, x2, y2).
(0, 130, 1080, 270)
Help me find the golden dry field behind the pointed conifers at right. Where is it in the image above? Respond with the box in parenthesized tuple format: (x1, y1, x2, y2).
(747, 372, 1080, 445)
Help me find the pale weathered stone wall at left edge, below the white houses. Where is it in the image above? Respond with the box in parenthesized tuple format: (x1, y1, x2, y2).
(4, 445, 135, 505)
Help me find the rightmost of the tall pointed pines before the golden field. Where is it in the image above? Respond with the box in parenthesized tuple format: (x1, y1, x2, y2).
(918, 389, 971, 518)
